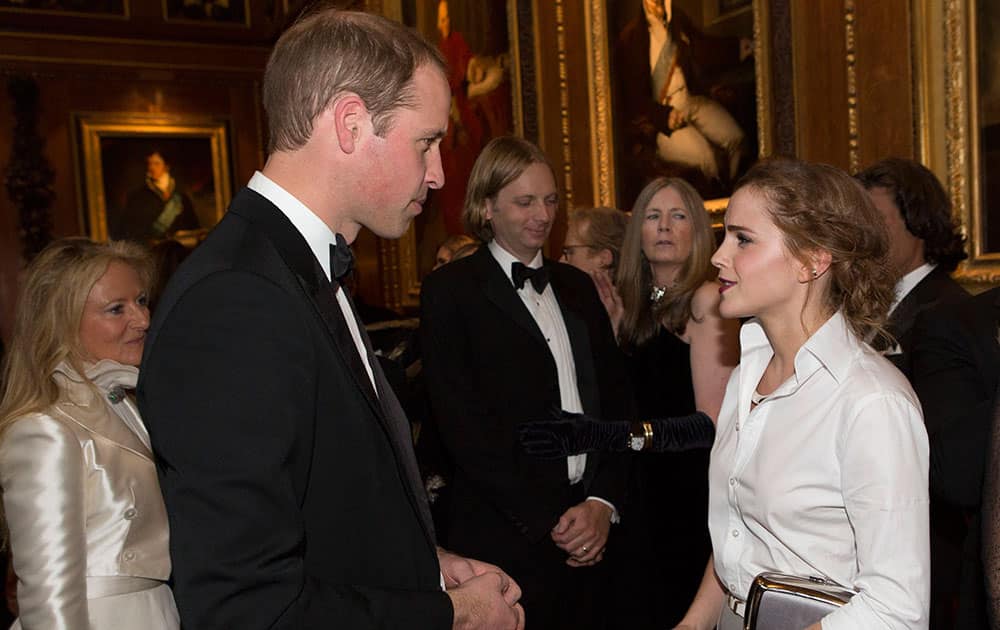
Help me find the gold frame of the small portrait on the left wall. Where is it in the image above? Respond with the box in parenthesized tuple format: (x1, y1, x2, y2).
(74, 113, 232, 245)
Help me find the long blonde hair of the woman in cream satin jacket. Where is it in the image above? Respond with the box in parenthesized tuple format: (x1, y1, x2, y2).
(0, 237, 153, 435)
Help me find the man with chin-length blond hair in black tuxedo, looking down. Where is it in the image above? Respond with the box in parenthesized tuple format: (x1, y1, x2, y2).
(420, 137, 631, 630)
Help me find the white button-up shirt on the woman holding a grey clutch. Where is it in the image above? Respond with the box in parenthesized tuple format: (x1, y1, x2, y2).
(709, 313, 930, 630)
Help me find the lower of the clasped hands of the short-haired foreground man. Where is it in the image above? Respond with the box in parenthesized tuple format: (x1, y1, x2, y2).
(447, 573, 524, 630)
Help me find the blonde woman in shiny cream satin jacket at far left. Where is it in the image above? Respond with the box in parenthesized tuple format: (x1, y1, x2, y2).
(0, 238, 179, 630)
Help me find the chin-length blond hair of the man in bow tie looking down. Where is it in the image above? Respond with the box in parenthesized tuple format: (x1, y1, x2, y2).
(462, 136, 555, 243)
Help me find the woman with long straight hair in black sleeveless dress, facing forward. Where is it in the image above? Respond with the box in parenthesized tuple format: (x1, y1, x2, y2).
(612, 177, 739, 628)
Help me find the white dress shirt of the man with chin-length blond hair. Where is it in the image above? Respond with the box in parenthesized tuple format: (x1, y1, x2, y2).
(487, 241, 618, 522)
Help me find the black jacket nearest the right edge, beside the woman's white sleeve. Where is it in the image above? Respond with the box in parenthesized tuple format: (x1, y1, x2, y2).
(911, 289, 1000, 629)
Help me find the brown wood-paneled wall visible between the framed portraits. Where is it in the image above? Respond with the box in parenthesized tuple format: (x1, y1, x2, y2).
(0, 0, 918, 346)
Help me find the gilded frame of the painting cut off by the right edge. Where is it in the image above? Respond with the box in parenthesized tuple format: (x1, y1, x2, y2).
(911, 0, 1000, 285)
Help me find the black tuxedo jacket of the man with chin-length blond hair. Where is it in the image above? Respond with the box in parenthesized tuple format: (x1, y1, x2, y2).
(420, 246, 632, 568)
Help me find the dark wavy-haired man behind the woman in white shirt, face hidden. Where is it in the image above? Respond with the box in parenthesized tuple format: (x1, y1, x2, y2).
(855, 158, 969, 378)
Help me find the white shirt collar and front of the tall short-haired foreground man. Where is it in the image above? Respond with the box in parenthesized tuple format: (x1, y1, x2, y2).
(247, 171, 378, 393)
